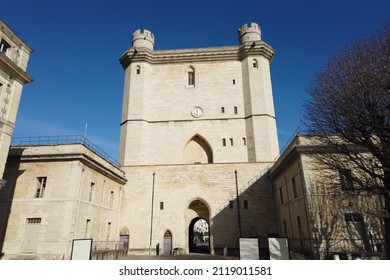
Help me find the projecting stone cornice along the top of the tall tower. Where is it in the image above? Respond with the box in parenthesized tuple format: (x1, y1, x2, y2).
(119, 41, 274, 69)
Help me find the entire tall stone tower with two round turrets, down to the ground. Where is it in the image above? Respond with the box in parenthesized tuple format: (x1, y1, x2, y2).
(119, 23, 279, 258)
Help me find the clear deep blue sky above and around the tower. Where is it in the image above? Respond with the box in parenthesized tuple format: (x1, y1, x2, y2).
(0, 0, 390, 158)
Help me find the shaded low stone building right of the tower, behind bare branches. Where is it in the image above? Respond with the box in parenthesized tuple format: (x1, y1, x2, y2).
(270, 135, 384, 259)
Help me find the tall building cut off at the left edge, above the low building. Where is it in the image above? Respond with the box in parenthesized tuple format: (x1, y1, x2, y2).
(0, 19, 32, 188)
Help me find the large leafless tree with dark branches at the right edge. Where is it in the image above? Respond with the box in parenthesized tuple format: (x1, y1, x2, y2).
(303, 24, 390, 259)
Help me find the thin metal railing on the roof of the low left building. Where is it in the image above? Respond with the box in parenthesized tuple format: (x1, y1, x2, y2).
(11, 135, 119, 167)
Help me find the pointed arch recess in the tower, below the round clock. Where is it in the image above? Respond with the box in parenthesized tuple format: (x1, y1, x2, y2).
(183, 135, 213, 164)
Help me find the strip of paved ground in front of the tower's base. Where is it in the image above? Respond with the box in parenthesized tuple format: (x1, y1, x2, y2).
(121, 253, 238, 260)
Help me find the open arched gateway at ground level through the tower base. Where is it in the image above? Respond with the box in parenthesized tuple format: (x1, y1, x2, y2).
(186, 199, 211, 254)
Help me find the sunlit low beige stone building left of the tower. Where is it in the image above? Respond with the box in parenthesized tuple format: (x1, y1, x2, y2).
(0, 142, 125, 259)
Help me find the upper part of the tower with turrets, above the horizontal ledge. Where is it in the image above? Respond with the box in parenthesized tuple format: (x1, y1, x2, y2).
(119, 23, 278, 166)
